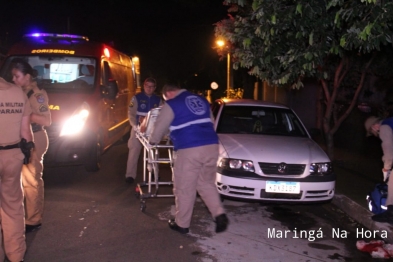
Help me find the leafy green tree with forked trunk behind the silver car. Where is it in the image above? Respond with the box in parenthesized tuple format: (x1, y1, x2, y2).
(215, 0, 393, 159)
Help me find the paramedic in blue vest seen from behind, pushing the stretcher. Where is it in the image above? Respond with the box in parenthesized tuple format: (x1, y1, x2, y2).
(149, 84, 229, 234)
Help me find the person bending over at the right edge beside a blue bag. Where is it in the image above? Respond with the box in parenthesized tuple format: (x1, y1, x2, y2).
(364, 116, 393, 224)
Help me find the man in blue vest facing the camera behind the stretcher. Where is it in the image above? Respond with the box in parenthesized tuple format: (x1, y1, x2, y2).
(126, 77, 161, 184)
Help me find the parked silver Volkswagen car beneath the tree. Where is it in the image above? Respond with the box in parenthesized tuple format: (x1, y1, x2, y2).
(212, 99, 336, 202)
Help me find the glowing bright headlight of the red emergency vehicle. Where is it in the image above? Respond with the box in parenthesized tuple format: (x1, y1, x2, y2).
(60, 102, 90, 136)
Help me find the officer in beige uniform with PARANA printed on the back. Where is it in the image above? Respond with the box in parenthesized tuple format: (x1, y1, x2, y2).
(0, 78, 34, 262)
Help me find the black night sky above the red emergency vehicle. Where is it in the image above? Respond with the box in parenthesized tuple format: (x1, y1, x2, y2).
(0, 0, 228, 90)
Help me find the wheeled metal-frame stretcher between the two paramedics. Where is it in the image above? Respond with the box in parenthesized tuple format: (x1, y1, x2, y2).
(135, 108, 174, 212)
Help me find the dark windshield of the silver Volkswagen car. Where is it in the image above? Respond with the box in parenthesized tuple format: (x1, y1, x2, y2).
(216, 106, 308, 137)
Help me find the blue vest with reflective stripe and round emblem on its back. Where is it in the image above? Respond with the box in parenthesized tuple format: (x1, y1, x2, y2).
(167, 91, 218, 151)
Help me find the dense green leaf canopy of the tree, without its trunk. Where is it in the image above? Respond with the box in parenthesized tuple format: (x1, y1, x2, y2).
(216, 0, 393, 87)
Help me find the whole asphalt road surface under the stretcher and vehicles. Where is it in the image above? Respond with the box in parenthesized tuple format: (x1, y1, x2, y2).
(25, 142, 375, 262)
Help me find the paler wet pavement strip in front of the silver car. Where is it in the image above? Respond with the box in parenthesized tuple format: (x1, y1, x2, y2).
(185, 200, 373, 262)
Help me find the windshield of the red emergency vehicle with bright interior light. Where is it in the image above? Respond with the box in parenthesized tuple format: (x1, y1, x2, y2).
(0, 55, 96, 93)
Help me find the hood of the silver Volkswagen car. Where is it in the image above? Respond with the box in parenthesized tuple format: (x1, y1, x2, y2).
(218, 134, 330, 164)
